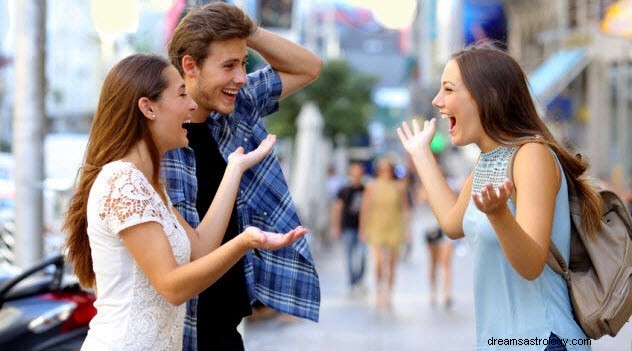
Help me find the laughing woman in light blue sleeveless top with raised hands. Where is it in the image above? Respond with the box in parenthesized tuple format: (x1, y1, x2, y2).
(397, 43, 601, 351)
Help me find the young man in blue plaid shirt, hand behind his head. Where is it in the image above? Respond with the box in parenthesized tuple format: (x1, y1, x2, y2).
(163, 2, 322, 351)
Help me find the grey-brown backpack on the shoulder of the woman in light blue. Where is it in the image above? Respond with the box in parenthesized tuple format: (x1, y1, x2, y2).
(547, 176, 632, 339)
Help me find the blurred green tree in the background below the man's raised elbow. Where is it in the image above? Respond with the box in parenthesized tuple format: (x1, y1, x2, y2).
(266, 60, 377, 142)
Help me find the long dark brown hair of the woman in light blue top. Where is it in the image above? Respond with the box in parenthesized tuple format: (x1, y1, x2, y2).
(452, 42, 603, 233)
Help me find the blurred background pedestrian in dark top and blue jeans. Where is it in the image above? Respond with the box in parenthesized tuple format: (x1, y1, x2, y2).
(331, 163, 366, 292)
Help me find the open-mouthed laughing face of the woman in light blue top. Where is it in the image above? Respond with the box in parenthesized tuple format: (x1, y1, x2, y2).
(432, 60, 497, 152)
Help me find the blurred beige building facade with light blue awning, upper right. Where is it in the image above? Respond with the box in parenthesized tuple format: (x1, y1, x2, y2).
(505, 0, 632, 191)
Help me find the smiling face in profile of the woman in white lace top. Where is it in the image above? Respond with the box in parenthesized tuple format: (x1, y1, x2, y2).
(149, 65, 197, 153)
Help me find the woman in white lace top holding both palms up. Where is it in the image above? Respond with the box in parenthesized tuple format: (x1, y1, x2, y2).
(64, 54, 306, 351)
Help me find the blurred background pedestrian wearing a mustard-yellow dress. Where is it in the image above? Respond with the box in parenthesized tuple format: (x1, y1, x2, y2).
(359, 158, 409, 306)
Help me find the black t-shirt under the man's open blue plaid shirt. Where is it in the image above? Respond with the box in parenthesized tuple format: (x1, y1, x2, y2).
(185, 123, 252, 322)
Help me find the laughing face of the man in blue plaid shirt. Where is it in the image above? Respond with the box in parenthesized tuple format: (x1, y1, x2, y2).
(187, 38, 248, 122)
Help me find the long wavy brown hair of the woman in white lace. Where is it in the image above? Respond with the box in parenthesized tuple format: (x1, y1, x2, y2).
(62, 54, 170, 287)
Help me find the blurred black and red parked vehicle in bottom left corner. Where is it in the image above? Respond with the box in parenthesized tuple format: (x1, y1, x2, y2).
(0, 255, 96, 351)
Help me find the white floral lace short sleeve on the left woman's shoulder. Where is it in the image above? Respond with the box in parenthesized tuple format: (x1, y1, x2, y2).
(99, 167, 162, 234)
